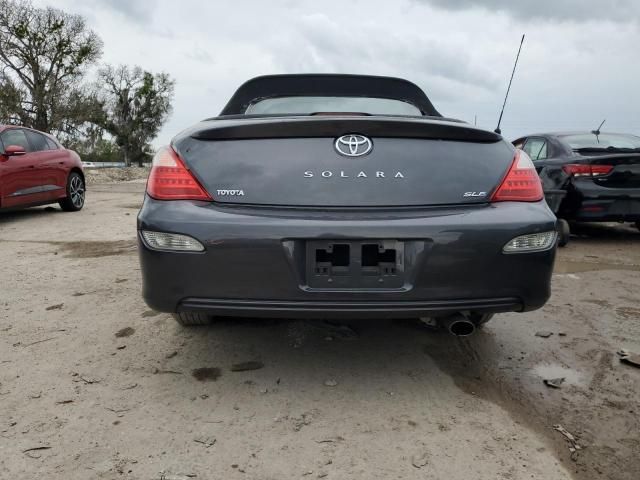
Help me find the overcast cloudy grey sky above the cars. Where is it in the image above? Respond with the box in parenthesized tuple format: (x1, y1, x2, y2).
(35, 0, 640, 145)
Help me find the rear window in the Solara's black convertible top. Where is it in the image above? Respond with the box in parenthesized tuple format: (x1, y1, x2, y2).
(245, 96, 422, 116)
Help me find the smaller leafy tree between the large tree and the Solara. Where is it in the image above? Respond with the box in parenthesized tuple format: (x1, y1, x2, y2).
(99, 66, 174, 166)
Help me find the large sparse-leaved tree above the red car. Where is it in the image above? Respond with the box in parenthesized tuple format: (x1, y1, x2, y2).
(0, 0, 102, 135)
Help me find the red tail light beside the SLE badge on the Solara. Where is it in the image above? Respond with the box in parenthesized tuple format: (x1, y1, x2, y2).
(491, 150, 544, 202)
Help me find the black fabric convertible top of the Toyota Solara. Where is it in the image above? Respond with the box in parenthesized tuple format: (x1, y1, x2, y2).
(220, 74, 442, 117)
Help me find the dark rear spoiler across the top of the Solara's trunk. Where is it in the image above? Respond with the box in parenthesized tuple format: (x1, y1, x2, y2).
(188, 116, 502, 143)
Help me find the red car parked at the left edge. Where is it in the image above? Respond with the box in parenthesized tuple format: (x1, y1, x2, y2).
(0, 125, 85, 212)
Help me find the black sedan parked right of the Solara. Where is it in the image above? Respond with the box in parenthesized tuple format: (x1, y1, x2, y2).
(513, 131, 640, 243)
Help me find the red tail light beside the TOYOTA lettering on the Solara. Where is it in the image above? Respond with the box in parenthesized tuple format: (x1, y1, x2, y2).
(147, 147, 212, 201)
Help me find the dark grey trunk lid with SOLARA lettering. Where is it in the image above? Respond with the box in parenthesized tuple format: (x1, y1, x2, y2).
(173, 117, 514, 207)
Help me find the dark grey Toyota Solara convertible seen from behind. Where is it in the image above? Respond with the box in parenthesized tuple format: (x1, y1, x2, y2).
(138, 75, 556, 324)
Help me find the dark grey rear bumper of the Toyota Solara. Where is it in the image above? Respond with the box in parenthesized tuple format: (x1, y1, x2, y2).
(138, 198, 556, 318)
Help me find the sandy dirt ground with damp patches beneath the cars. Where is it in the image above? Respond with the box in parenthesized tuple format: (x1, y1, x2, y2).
(0, 180, 640, 480)
